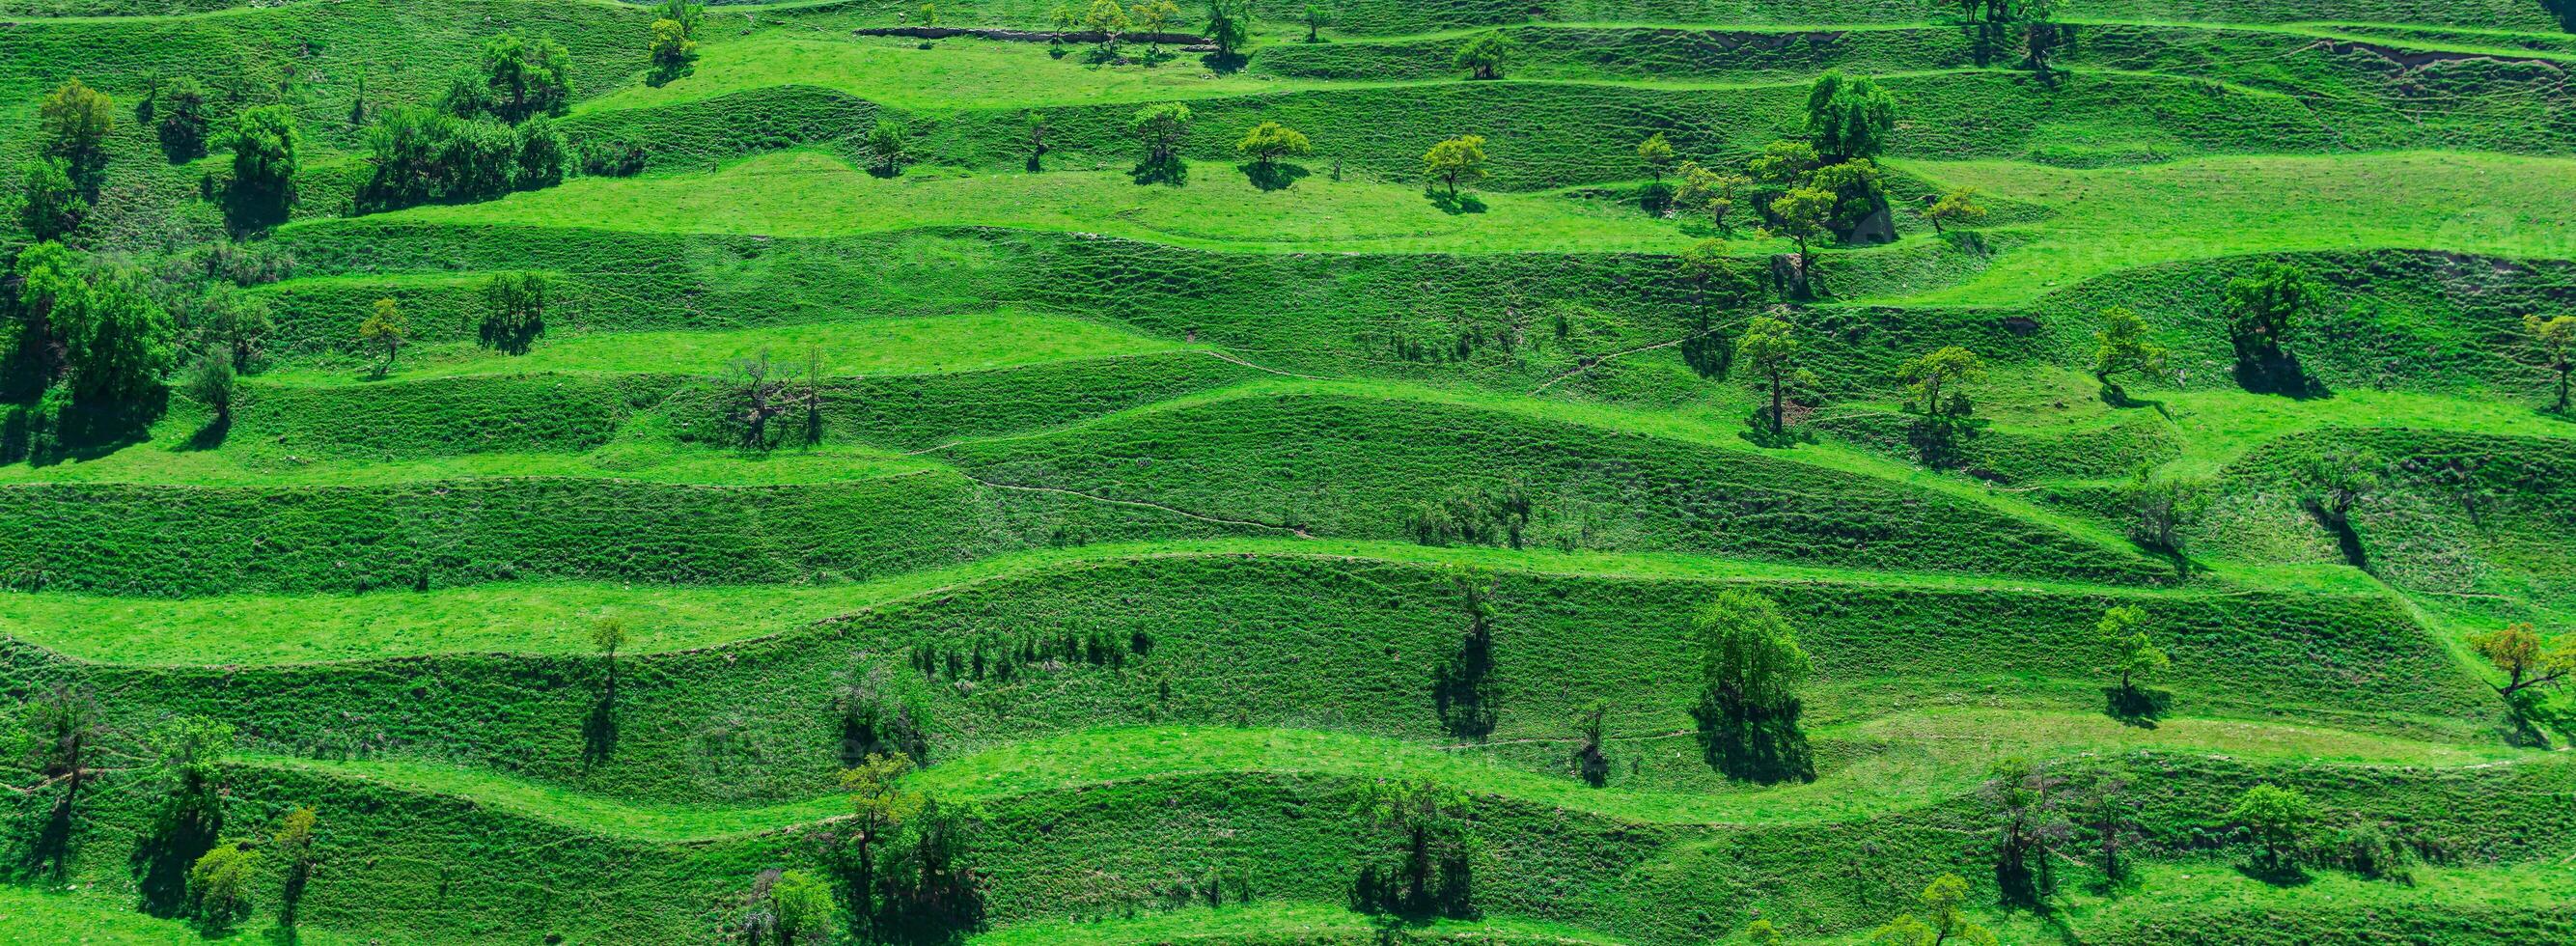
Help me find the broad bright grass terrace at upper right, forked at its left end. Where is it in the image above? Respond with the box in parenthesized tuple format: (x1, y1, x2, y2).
(1888, 153, 2576, 304)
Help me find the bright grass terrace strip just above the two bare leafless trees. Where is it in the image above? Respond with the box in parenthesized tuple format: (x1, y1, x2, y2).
(261, 307, 1182, 384)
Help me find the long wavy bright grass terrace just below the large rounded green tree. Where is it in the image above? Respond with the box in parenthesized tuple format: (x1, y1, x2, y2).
(232, 711, 2545, 843)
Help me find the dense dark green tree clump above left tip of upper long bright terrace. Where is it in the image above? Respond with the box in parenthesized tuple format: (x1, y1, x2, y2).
(358, 34, 579, 209)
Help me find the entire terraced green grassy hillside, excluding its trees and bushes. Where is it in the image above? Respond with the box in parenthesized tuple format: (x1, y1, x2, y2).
(0, 0, 2576, 943)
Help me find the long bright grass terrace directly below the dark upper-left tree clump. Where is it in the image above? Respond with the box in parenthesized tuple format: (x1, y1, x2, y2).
(389, 153, 1690, 253)
